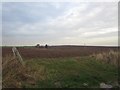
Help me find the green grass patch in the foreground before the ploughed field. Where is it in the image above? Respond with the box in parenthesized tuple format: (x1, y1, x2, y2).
(24, 57, 118, 88)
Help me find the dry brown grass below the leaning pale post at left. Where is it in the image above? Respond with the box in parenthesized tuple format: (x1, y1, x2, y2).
(2, 55, 35, 88)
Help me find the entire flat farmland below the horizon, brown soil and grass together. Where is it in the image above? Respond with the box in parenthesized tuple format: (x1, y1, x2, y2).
(2, 46, 119, 88)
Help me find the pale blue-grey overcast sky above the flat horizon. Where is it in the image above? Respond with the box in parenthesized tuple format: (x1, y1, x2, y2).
(2, 2, 118, 45)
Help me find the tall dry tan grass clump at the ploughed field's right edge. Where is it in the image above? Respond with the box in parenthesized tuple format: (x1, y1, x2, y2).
(91, 50, 120, 66)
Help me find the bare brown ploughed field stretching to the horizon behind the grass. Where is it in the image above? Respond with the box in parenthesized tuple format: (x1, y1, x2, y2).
(2, 46, 118, 59)
